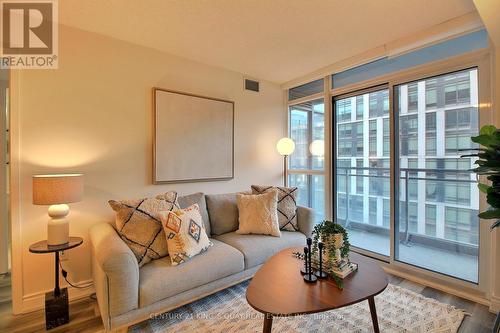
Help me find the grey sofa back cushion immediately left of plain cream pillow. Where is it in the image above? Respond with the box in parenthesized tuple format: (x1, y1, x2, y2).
(205, 193, 238, 235)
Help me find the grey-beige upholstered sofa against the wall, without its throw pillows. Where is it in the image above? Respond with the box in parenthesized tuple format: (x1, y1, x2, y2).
(90, 193, 314, 331)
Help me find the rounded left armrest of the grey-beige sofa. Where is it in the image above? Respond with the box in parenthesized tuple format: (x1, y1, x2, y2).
(90, 223, 139, 329)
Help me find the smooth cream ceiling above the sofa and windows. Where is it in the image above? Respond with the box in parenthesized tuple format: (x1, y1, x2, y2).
(59, 0, 475, 84)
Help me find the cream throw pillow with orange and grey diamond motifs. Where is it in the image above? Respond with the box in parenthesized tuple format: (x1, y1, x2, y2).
(160, 204, 213, 265)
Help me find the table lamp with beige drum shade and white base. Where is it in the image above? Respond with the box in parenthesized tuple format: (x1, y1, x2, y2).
(33, 174, 83, 245)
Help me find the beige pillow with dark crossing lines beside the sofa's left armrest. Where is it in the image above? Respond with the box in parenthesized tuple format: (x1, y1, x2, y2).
(109, 191, 180, 267)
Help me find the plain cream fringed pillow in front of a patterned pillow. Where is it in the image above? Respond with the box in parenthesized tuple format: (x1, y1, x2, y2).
(236, 190, 281, 237)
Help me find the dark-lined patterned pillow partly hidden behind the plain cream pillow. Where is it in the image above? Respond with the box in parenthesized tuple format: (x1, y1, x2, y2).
(252, 185, 299, 231)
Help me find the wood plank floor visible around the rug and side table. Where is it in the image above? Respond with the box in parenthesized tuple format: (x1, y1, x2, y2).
(0, 275, 496, 333)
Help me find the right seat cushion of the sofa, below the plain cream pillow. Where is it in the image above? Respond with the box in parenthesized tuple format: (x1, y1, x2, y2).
(216, 231, 306, 269)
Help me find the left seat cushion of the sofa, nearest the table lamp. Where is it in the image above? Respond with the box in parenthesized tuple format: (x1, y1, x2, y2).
(139, 239, 244, 308)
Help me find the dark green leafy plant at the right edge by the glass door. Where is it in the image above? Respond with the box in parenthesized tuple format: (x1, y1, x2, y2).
(462, 125, 500, 230)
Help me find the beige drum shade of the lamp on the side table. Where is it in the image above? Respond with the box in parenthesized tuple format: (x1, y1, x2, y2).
(33, 174, 83, 205)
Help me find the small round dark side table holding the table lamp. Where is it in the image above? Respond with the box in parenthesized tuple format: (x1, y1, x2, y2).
(30, 237, 83, 330)
